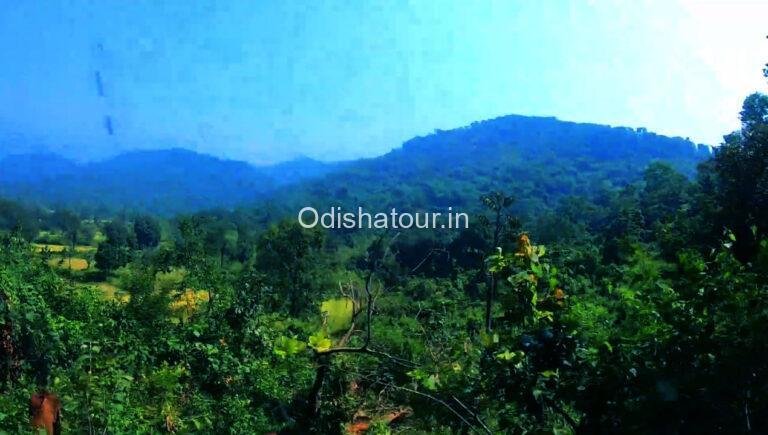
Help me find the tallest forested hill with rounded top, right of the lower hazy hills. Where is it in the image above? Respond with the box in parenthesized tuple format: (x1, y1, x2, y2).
(266, 115, 711, 220)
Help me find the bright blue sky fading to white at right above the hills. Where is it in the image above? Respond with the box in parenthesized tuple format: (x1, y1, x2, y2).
(0, 0, 768, 164)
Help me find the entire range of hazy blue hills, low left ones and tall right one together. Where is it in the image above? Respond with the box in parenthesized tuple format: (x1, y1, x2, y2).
(0, 115, 710, 216)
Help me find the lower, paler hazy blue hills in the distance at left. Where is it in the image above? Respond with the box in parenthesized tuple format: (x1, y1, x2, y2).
(0, 149, 339, 216)
